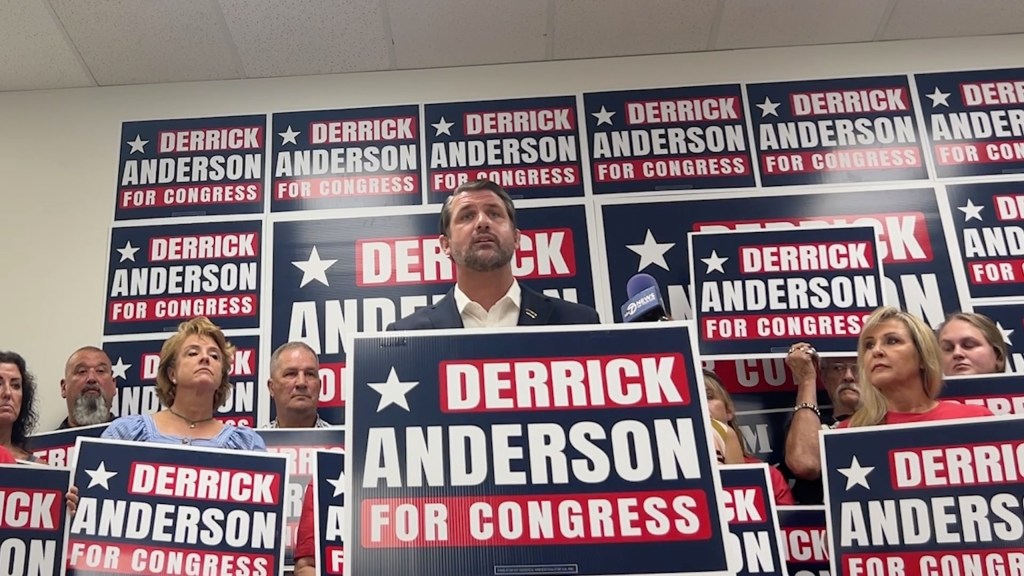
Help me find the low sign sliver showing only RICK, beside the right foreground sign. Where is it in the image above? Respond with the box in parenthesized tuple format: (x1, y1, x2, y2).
(775, 506, 831, 576)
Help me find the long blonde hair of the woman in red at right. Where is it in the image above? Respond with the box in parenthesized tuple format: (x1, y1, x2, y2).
(850, 306, 942, 427)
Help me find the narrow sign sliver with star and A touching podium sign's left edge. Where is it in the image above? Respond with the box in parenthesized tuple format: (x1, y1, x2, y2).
(313, 450, 349, 576)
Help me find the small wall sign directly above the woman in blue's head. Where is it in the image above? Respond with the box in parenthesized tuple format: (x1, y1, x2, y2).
(103, 220, 263, 335)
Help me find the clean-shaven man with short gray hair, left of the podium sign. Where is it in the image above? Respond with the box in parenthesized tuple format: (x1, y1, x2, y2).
(266, 341, 332, 428)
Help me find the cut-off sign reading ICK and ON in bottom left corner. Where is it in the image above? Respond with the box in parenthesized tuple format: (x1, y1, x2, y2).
(0, 464, 70, 576)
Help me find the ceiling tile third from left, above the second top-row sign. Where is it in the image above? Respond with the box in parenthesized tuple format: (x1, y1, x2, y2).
(219, 0, 389, 78)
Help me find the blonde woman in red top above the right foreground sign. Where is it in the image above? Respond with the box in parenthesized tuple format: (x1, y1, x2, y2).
(840, 306, 992, 427)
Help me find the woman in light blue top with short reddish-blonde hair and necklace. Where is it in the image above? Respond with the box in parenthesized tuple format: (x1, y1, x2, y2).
(103, 316, 266, 451)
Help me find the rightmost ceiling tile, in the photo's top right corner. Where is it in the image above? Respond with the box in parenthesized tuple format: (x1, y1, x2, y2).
(881, 0, 1024, 40)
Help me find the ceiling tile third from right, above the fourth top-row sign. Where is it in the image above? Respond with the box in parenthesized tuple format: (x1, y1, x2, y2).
(553, 0, 716, 59)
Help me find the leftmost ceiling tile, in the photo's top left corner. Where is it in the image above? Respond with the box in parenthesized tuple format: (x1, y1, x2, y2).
(0, 0, 95, 90)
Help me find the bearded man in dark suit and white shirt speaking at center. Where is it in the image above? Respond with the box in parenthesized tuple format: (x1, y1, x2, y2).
(388, 180, 601, 330)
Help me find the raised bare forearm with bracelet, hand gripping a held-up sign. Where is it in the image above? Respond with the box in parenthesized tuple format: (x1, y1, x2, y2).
(785, 342, 821, 480)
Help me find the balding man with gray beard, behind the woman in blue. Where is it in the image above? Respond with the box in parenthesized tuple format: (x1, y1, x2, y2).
(57, 346, 117, 429)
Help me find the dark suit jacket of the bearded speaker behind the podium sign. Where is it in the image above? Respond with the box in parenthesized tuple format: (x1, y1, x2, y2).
(387, 283, 601, 330)
